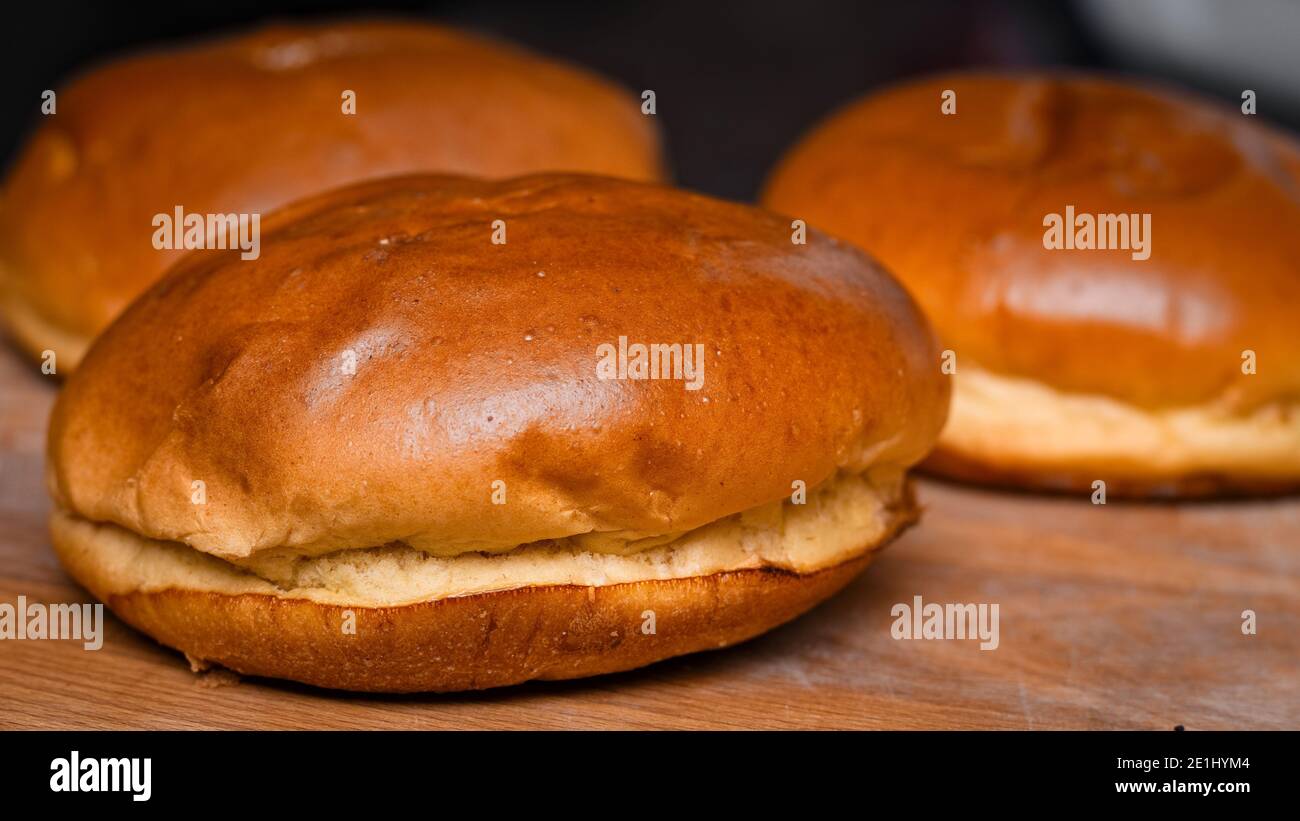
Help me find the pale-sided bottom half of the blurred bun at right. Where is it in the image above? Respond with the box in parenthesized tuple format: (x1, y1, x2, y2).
(920, 366, 1300, 499)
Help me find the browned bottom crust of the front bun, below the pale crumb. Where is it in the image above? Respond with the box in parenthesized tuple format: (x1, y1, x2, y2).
(53, 508, 915, 692)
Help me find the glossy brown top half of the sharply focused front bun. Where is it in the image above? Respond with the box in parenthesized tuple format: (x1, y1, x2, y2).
(48, 175, 949, 560)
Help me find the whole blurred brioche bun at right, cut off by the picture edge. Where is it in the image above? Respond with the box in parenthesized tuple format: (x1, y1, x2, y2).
(763, 73, 1300, 496)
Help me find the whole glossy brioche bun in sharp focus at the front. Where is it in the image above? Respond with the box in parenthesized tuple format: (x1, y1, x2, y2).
(48, 174, 948, 690)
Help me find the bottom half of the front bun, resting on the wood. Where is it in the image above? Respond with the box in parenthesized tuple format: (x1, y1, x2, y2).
(51, 475, 919, 692)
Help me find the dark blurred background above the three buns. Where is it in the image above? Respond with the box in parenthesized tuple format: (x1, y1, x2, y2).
(0, 0, 1300, 199)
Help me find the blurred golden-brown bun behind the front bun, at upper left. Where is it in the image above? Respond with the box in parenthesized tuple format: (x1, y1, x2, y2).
(0, 22, 663, 373)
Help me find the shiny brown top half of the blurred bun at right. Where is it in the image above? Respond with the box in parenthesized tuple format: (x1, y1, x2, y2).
(763, 73, 1300, 412)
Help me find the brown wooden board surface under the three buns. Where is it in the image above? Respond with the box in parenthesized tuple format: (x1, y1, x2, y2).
(0, 347, 1300, 729)
